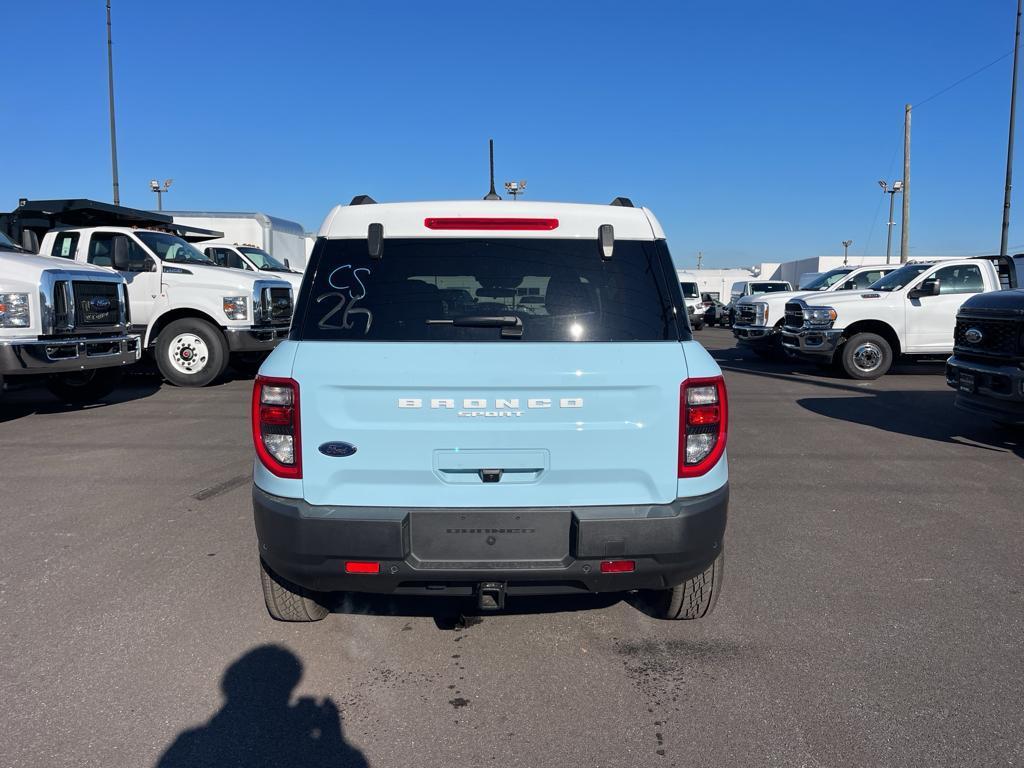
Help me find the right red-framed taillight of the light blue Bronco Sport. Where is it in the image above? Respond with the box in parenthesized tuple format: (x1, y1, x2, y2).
(679, 376, 729, 477)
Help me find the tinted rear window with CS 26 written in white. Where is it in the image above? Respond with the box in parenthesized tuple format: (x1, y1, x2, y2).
(292, 238, 690, 343)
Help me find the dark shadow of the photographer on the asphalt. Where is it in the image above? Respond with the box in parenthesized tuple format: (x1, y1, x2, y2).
(157, 645, 369, 768)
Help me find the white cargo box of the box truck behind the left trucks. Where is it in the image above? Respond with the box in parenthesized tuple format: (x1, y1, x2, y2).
(162, 211, 306, 270)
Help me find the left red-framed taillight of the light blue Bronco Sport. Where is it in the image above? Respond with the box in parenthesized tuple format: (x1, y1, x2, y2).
(252, 376, 302, 479)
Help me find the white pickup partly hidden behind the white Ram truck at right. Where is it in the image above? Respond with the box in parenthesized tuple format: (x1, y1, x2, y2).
(732, 264, 899, 357)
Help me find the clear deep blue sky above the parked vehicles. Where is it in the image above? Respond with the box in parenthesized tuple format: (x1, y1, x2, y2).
(0, 0, 1024, 266)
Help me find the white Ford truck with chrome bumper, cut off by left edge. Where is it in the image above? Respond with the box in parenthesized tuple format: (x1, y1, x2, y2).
(0, 231, 141, 402)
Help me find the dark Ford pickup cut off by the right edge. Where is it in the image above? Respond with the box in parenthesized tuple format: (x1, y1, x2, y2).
(946, 257, 1024, 427)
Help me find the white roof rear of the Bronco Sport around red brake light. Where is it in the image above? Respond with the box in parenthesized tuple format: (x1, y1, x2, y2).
(318, 199, 665, 240)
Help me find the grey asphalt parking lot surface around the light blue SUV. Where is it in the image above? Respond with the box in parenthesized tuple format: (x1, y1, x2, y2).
(0, 329, 1024, 767)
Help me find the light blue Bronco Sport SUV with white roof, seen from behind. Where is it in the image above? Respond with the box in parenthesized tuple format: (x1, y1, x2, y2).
(252, 196, 729, 622)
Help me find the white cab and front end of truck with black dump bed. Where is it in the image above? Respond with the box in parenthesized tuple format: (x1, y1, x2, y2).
(40, 226, 293, 387)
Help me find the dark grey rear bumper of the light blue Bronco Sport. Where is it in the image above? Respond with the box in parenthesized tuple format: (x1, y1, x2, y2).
(253, 485, 729, 596)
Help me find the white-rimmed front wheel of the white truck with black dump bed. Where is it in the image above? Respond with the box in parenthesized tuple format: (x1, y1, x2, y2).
(157, 317, 227, 387)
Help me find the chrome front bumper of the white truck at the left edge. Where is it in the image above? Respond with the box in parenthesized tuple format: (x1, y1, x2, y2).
(0, 334, 141, 376)
